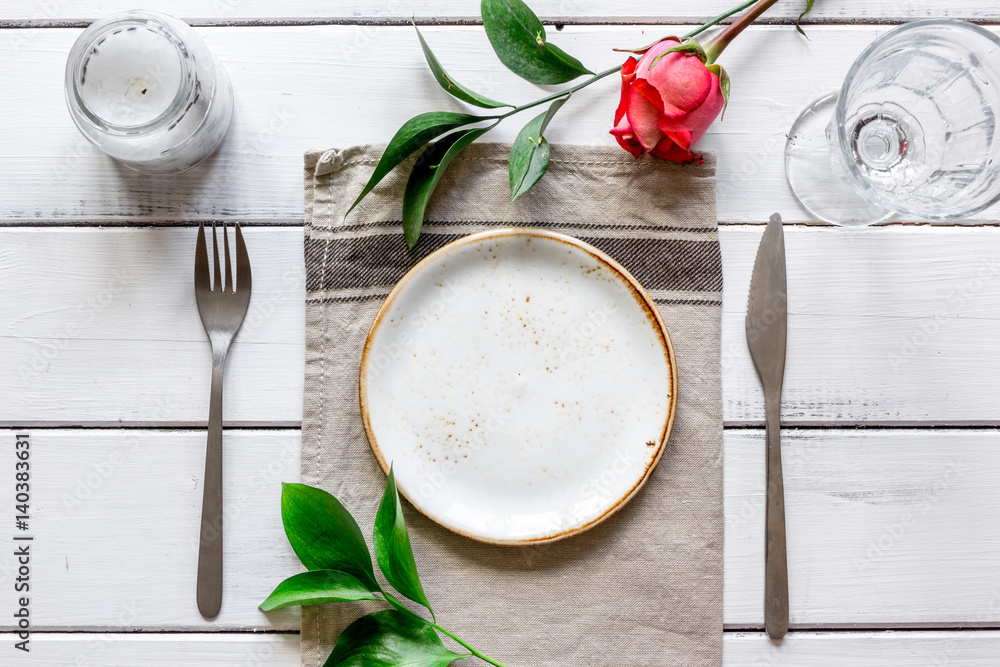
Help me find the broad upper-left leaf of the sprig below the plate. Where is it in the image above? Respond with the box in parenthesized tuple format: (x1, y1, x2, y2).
(281, 483, 379, 591)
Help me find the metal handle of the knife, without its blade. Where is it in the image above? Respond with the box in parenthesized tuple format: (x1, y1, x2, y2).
(764, 398, 788, 639)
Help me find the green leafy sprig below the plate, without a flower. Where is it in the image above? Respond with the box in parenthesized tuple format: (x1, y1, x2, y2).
(260, 469, 504, 667)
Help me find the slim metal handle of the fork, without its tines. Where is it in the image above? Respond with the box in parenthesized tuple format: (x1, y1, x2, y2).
(198, 355, 226, 618)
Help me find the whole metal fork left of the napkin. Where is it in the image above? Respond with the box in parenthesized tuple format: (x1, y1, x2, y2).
(194, 223, 252, 618)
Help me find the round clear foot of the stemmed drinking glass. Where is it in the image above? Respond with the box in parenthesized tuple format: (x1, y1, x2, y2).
(785, 93, 893, 226)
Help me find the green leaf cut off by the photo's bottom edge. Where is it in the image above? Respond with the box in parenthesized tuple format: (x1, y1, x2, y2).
(324, 609, 468, 667)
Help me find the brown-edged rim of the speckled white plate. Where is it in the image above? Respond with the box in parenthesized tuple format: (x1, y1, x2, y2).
(358, 227, 677, 546)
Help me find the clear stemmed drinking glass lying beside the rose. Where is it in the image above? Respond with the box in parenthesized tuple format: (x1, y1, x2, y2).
(785, 19, 1000, 225)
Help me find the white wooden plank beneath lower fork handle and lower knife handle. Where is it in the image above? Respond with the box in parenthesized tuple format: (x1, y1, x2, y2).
(0, 429, 1000, 631)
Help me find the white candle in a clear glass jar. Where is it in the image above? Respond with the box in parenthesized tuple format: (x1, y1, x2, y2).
(66, 11, 233, 173)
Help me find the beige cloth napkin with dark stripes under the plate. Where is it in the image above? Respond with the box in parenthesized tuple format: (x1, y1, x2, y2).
(302, 144, 723, 667)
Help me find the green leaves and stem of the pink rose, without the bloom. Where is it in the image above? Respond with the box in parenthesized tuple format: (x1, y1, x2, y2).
(345, 0, 814, 249)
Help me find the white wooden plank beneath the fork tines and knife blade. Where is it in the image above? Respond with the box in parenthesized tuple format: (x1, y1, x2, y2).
(0, 226, 1000, 426)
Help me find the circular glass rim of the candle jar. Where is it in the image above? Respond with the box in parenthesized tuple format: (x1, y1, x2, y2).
(65, 10, 191, 136)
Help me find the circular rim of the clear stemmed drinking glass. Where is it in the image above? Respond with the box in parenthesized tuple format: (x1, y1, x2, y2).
(833, 18, 1000, 222)
